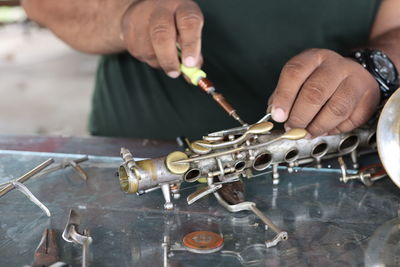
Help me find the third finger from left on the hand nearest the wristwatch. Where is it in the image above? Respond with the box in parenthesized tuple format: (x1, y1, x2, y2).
(307, 78, 365, 136)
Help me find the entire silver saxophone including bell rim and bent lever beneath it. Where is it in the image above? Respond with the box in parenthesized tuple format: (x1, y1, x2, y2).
(118, 90, 400, 248)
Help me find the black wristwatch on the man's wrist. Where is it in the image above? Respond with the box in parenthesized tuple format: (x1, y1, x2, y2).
(350, 49, 399, 100)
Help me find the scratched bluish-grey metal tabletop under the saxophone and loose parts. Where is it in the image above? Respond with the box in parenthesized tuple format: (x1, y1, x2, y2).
(0, 151, 400, 266)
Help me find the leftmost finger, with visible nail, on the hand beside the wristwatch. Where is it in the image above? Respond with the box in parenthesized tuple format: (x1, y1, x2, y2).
(272, 49, 322, 122)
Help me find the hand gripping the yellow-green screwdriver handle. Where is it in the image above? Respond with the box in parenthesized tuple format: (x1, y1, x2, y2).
(121, 0, 203, 78)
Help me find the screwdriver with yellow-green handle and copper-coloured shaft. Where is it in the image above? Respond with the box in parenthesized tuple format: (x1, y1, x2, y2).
(178, 50, 247, 126)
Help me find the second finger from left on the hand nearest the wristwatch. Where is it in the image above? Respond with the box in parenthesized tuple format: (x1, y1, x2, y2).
(286, 65, 344, 128)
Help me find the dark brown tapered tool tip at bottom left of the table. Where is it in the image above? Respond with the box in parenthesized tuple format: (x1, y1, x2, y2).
(32, 228, 59, 267)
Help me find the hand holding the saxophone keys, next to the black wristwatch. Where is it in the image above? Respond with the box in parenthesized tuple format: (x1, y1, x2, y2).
(269, 49, 380, 137)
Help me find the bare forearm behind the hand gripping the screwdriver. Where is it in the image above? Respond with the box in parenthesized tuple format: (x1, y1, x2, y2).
(22, 0, 137, 54)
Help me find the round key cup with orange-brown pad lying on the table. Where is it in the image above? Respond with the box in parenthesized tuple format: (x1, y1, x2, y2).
(183, 231, 224, 253)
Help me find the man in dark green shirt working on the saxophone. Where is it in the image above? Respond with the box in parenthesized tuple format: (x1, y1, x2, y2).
(23, 0, 400, 139)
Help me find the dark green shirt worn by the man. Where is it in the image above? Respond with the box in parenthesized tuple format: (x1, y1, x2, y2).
(90, 0, 380, 139)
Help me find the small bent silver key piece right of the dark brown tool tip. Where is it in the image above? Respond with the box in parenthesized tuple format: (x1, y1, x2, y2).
(62, 209, 92, 267)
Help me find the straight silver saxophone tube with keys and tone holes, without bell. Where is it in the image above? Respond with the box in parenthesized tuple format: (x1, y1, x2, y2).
(118, 119, 376, 209)
